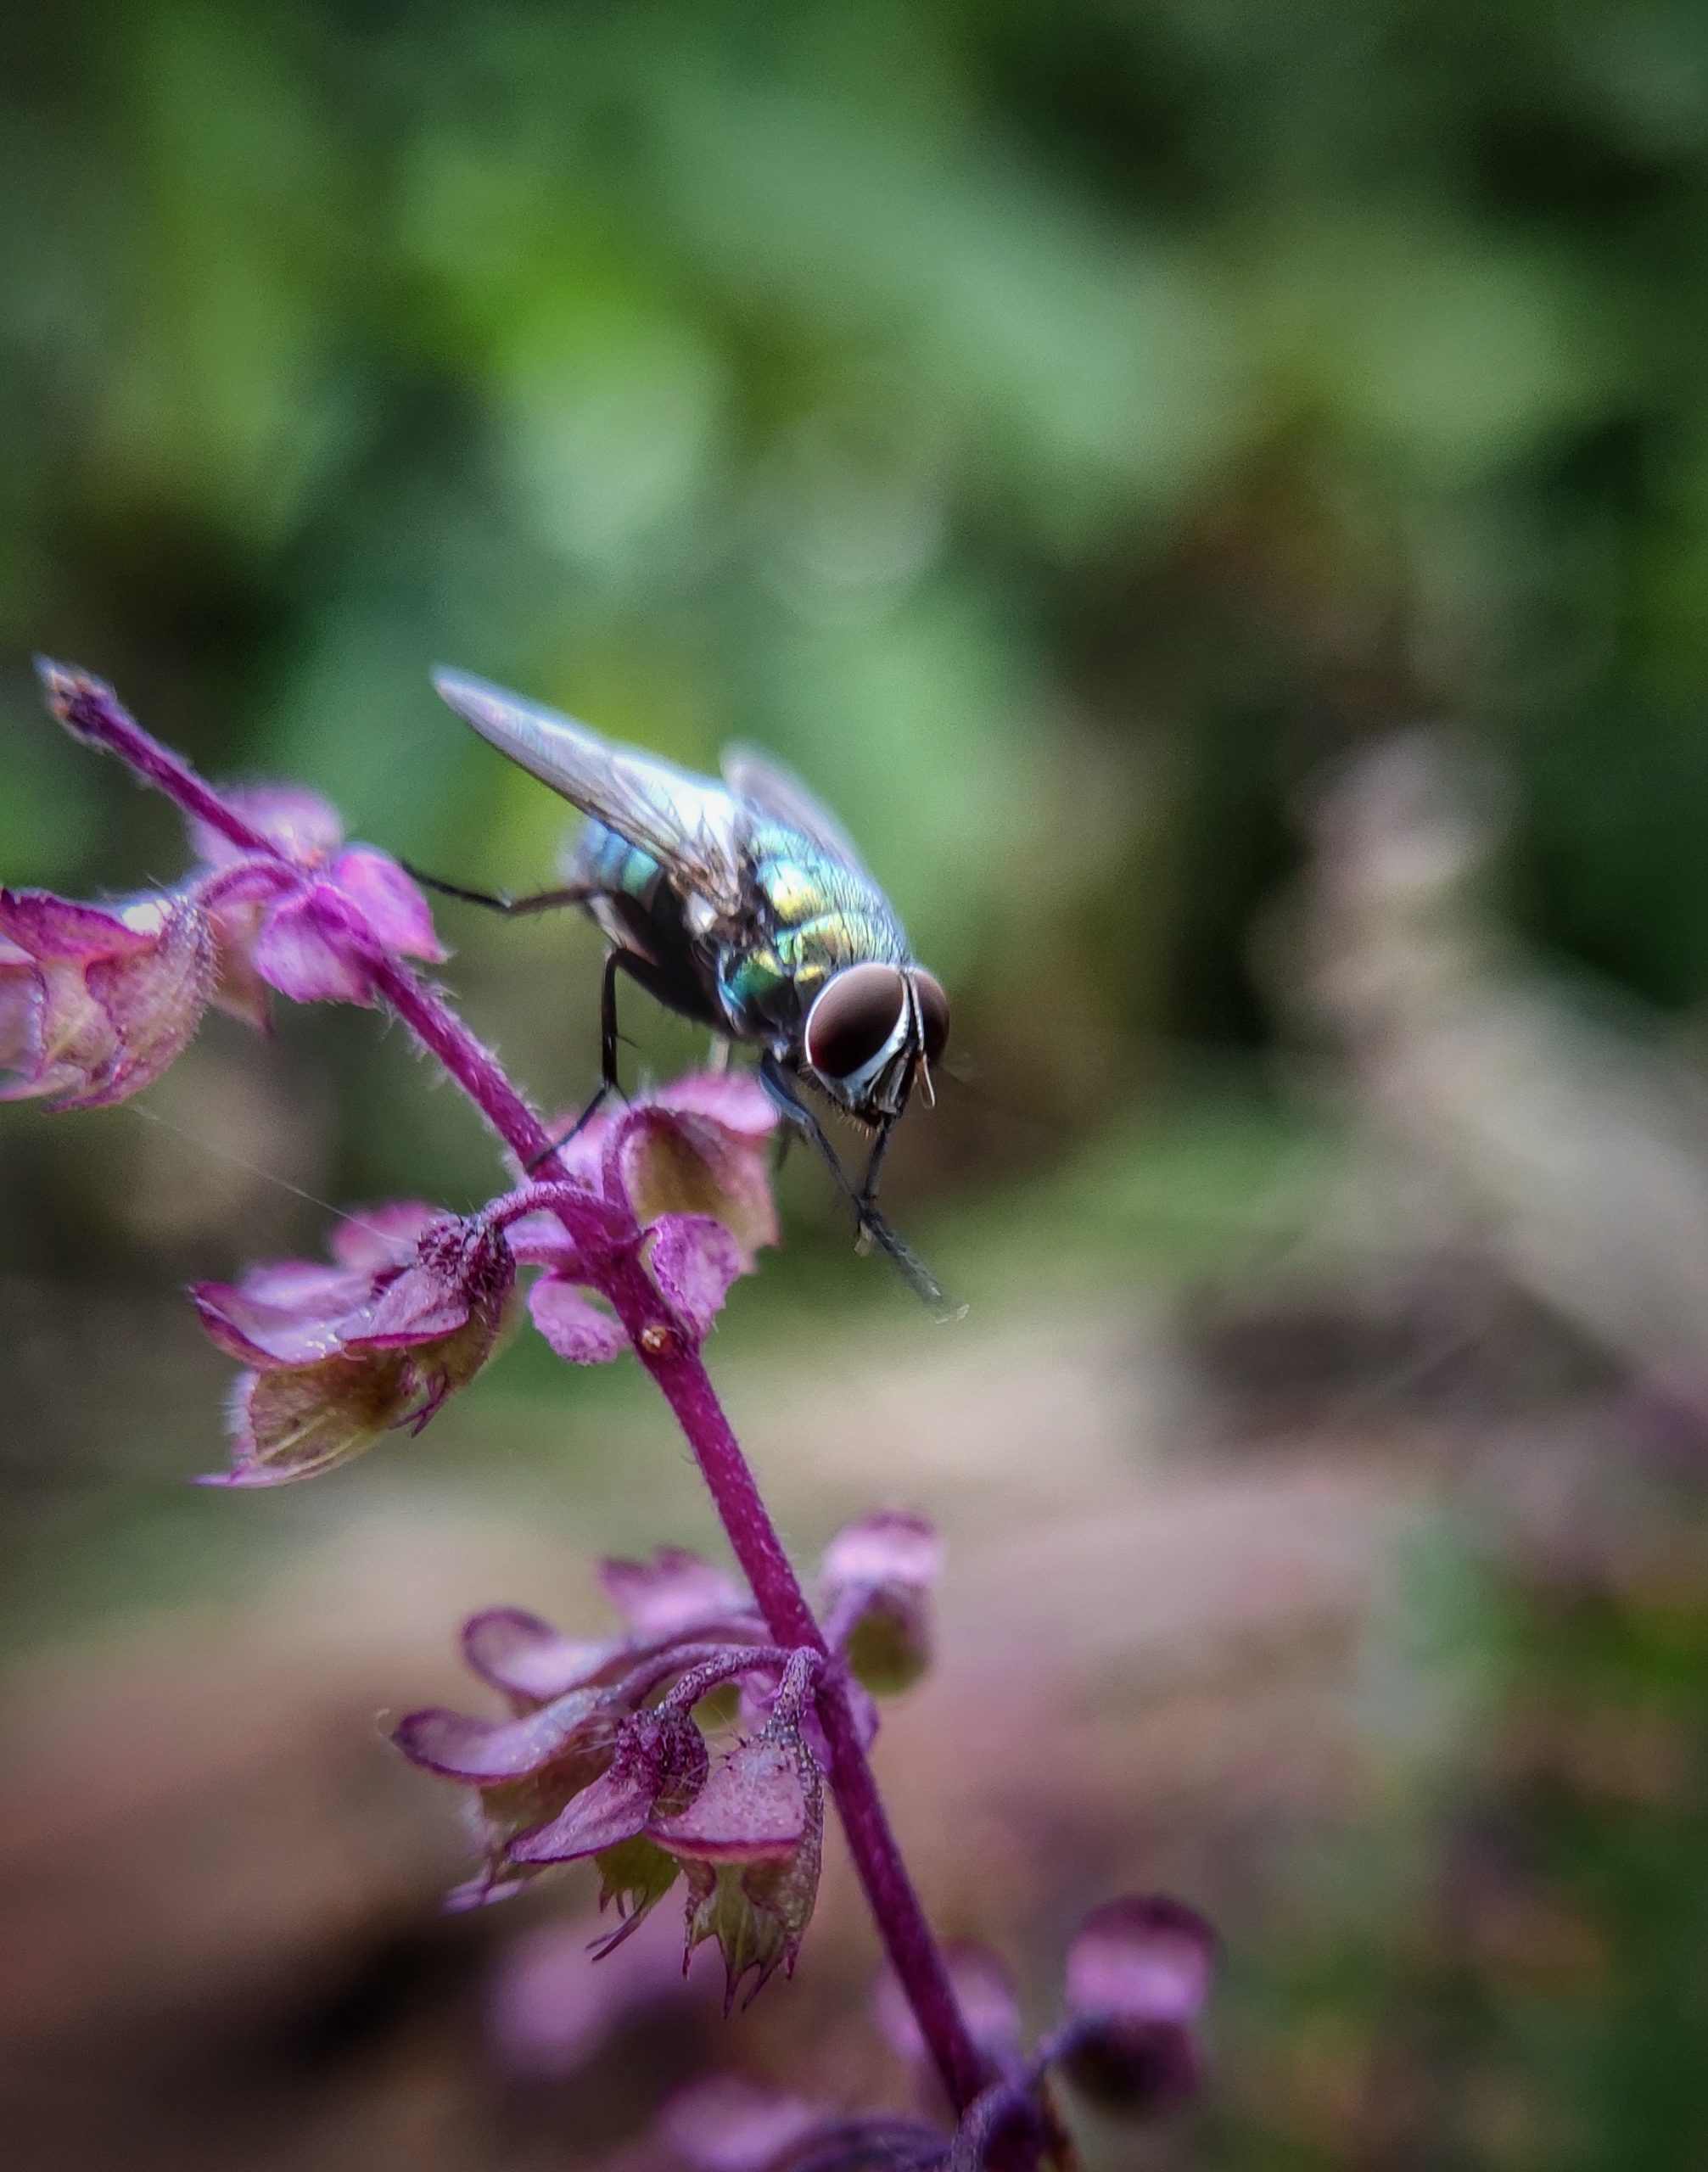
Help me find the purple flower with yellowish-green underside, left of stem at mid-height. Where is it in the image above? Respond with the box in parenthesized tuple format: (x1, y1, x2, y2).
(191, 1206, 515, 1486)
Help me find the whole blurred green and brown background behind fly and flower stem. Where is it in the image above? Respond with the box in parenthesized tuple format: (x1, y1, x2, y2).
(0, 0, 1708, 2172)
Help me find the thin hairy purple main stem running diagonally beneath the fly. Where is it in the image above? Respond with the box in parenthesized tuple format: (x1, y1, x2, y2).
(39, 660, 991, 2113)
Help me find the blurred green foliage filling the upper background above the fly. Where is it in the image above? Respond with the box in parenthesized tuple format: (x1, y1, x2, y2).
(0, 0, 1708, 1121)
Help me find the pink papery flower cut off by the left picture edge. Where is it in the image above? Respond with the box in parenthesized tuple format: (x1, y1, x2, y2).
(0, 891, 216, 1110)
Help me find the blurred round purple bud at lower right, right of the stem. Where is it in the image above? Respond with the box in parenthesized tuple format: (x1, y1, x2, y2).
(1061, 1894, 1217, 2113)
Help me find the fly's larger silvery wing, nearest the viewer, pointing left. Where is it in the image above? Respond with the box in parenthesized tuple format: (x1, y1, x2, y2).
(433, 671, 741, 915)
